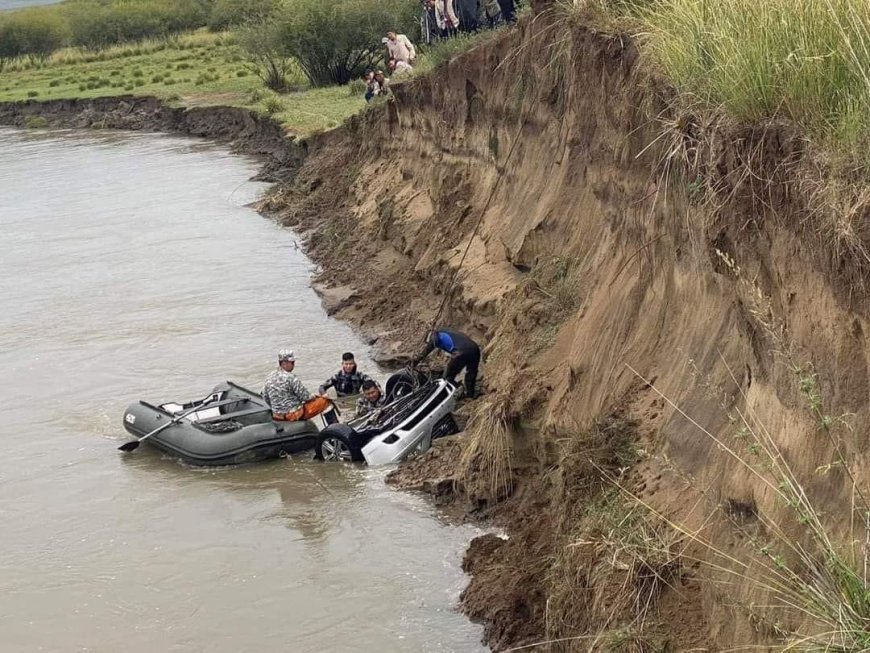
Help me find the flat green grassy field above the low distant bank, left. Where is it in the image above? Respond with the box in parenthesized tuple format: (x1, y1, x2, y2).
(0, 31, 365, 136)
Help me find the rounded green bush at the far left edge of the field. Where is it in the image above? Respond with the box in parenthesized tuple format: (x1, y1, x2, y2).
(0, 7, 67, 63)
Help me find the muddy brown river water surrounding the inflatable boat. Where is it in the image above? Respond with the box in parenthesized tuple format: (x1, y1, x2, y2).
(0, 130, 484, 653)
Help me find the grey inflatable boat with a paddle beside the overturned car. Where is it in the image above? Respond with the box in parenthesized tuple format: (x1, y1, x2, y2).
(124, 381, 331, 465)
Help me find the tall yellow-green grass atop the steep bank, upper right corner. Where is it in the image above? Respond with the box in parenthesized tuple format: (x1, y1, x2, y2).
(632, 0, 870, 162)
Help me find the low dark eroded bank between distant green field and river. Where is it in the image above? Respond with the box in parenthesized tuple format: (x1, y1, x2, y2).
(0, 96, 305, 181)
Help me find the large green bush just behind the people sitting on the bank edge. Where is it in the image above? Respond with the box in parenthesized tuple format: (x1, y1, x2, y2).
(274, 0, 419, 86)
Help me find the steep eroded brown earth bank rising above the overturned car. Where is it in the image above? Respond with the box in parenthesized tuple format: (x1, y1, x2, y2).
(6, 8, 870, 650)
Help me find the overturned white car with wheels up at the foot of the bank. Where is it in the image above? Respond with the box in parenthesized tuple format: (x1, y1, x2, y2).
(315, 371, 459, 465)
